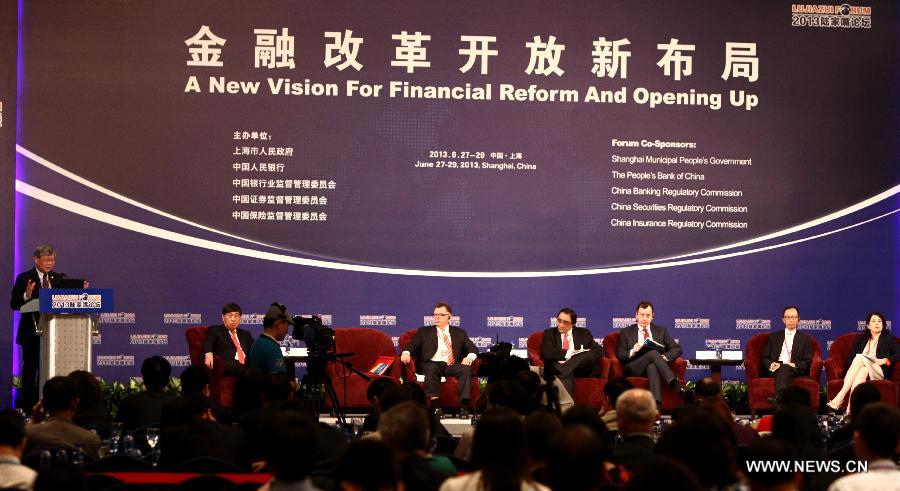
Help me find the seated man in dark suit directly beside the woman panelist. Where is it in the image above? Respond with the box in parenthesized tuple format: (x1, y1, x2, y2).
(762, 305, 812, 395)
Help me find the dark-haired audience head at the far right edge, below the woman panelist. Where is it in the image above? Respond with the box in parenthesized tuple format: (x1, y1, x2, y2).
(853, 402, 900, 460)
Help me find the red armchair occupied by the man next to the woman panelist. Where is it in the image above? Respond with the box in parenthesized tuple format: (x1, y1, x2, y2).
(744, 332, 822, 415)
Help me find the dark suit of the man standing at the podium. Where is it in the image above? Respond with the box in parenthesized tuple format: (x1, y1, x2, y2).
(9, 268, 62, 410)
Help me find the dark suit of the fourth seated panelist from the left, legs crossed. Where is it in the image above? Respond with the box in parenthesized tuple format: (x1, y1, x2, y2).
(616, 323, 681, 408)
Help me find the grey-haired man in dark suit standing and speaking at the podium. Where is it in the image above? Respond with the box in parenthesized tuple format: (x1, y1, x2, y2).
(9, 245, 88, 411)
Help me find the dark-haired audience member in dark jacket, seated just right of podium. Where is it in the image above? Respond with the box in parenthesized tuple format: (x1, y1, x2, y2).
(116, 356, 175, 430)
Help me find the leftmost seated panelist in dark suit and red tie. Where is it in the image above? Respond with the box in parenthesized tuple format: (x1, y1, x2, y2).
(203, 302, 253, 376)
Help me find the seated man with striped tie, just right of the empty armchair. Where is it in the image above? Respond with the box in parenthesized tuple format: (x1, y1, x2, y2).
(400, 302, 478, 417)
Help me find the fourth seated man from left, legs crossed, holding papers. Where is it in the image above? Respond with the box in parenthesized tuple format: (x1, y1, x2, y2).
(616, 300, 683, 407)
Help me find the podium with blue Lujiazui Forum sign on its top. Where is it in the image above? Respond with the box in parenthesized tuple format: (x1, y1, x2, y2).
(26, 288, 113, 387)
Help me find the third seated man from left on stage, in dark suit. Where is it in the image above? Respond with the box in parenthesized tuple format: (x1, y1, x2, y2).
(541, 307, 603, 408)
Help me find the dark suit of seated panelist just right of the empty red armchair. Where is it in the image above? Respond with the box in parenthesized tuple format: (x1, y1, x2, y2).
(403, 326, 478, 401)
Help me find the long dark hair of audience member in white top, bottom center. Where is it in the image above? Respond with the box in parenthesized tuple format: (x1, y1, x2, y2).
(472, 408, 528, 489)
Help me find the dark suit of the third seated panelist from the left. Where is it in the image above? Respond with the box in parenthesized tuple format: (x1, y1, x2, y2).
(541, 327, 603, 397)
